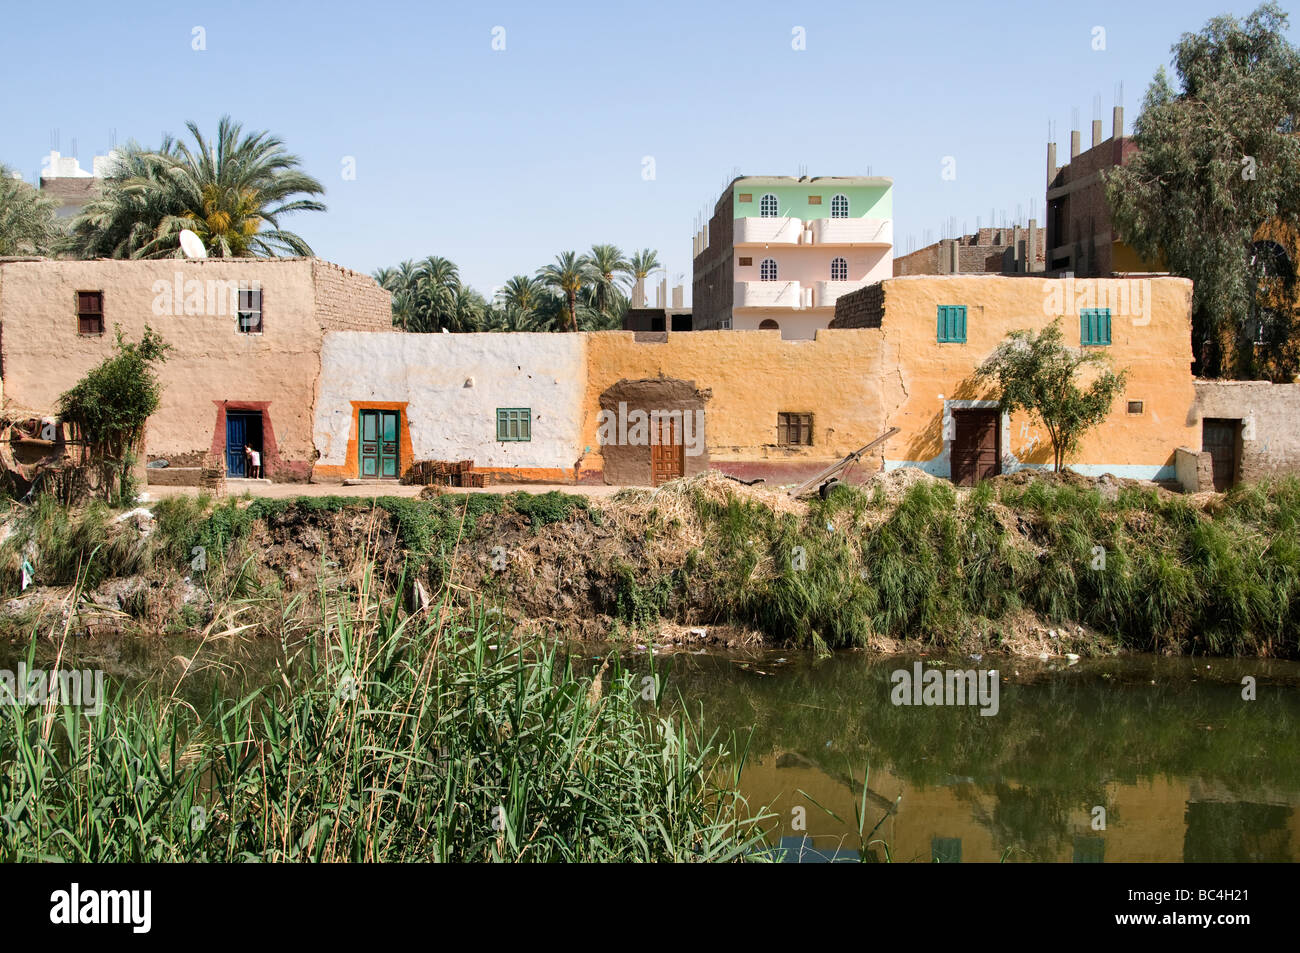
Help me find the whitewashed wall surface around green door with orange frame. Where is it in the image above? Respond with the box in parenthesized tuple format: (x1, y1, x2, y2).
(315, 332, 586, 468)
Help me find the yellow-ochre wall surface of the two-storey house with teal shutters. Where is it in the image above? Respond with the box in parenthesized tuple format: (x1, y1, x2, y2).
(881, 276, 1200, 478)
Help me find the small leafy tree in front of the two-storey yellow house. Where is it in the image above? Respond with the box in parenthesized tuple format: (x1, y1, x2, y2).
(975, 321, 1128, 472)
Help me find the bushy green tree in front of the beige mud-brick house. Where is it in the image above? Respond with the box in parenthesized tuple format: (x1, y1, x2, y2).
(59, 325, 170, 502)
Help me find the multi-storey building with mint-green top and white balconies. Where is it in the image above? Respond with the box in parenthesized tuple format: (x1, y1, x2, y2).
(692, 176, 893, 339)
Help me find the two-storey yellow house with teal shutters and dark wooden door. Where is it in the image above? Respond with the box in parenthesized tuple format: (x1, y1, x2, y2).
(831, 276, 1196, 484)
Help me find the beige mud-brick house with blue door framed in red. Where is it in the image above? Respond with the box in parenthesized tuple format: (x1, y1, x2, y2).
(0, 259, 393, 484)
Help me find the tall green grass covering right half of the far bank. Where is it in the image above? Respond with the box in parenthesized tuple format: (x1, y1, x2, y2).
(697, 478, 1300, 655)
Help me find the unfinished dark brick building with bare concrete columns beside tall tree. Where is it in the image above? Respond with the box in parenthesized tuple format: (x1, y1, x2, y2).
(1047, 105, 1161, 278)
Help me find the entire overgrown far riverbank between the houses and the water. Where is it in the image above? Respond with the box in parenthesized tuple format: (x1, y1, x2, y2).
(0, 469, 1300, 658)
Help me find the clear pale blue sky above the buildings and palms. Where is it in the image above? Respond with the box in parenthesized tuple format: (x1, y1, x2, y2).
(0, 0, 1297, 298)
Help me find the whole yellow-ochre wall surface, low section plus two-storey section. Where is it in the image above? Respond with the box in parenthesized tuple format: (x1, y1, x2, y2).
(580, 276, 1200, 478)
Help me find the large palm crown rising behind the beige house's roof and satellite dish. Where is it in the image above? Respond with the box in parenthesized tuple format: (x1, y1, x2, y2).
(66, 116, 325, 259)
